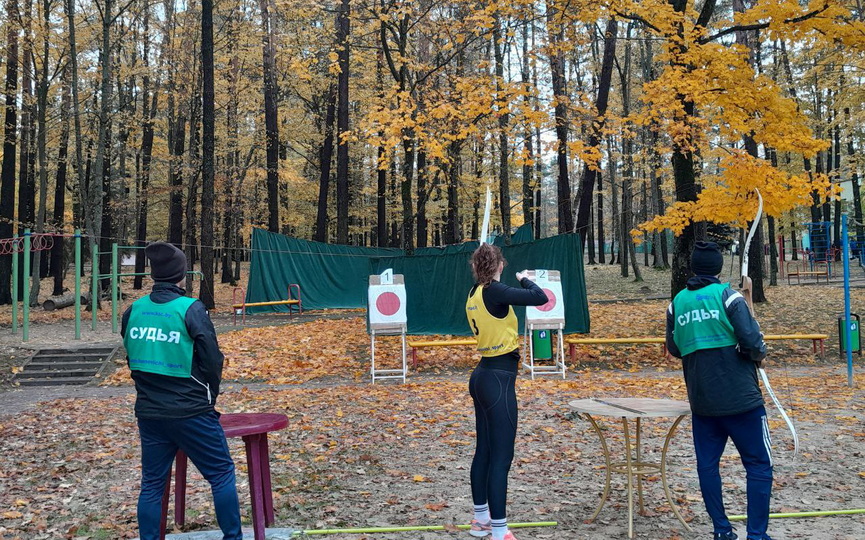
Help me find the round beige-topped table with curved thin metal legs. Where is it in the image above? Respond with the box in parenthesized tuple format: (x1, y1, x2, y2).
(568, 398, 691, 538)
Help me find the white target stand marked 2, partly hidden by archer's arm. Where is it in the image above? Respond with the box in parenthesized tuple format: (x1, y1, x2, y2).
(523, 270, 566, 380)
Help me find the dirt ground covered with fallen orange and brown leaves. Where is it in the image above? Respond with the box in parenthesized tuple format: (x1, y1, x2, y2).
(0, 266, 865, 540)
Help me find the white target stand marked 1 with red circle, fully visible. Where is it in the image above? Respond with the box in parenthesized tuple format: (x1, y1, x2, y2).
(367, 272, 408, 384)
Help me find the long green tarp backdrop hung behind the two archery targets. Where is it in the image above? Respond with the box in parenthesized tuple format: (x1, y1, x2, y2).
(246, 229, 589, 335)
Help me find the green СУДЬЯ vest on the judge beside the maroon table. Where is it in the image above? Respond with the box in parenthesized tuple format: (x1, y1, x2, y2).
(123, 295, 195, 378)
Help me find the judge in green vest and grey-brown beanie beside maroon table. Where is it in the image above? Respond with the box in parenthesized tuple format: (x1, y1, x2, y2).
(120, 242, 243, 540)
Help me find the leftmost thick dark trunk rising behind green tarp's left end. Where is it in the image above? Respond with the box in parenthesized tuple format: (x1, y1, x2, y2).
(258, 0, 279, 232)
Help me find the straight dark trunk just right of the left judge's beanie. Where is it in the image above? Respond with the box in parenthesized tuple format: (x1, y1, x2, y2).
(198, 0, 216, 309)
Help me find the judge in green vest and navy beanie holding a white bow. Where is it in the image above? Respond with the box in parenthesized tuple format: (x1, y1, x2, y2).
(667, 242, 772, 540)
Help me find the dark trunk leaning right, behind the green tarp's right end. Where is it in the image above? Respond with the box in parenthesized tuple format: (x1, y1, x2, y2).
(576, 18, 618, 251)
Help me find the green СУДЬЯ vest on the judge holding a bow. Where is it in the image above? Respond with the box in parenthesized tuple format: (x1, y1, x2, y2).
(673, 283, 738, 356)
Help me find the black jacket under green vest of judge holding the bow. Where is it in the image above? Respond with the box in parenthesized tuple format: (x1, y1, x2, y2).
(667, 276, 766, 416)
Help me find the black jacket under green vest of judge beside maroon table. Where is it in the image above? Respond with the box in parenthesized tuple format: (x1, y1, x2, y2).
(120, 282, 225, 418)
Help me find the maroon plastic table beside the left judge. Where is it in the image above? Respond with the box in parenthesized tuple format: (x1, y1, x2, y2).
(161, 413, 288, 540)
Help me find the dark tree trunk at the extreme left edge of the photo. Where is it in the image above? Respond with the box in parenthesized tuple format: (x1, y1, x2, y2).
(0, 0, 19, 305)
